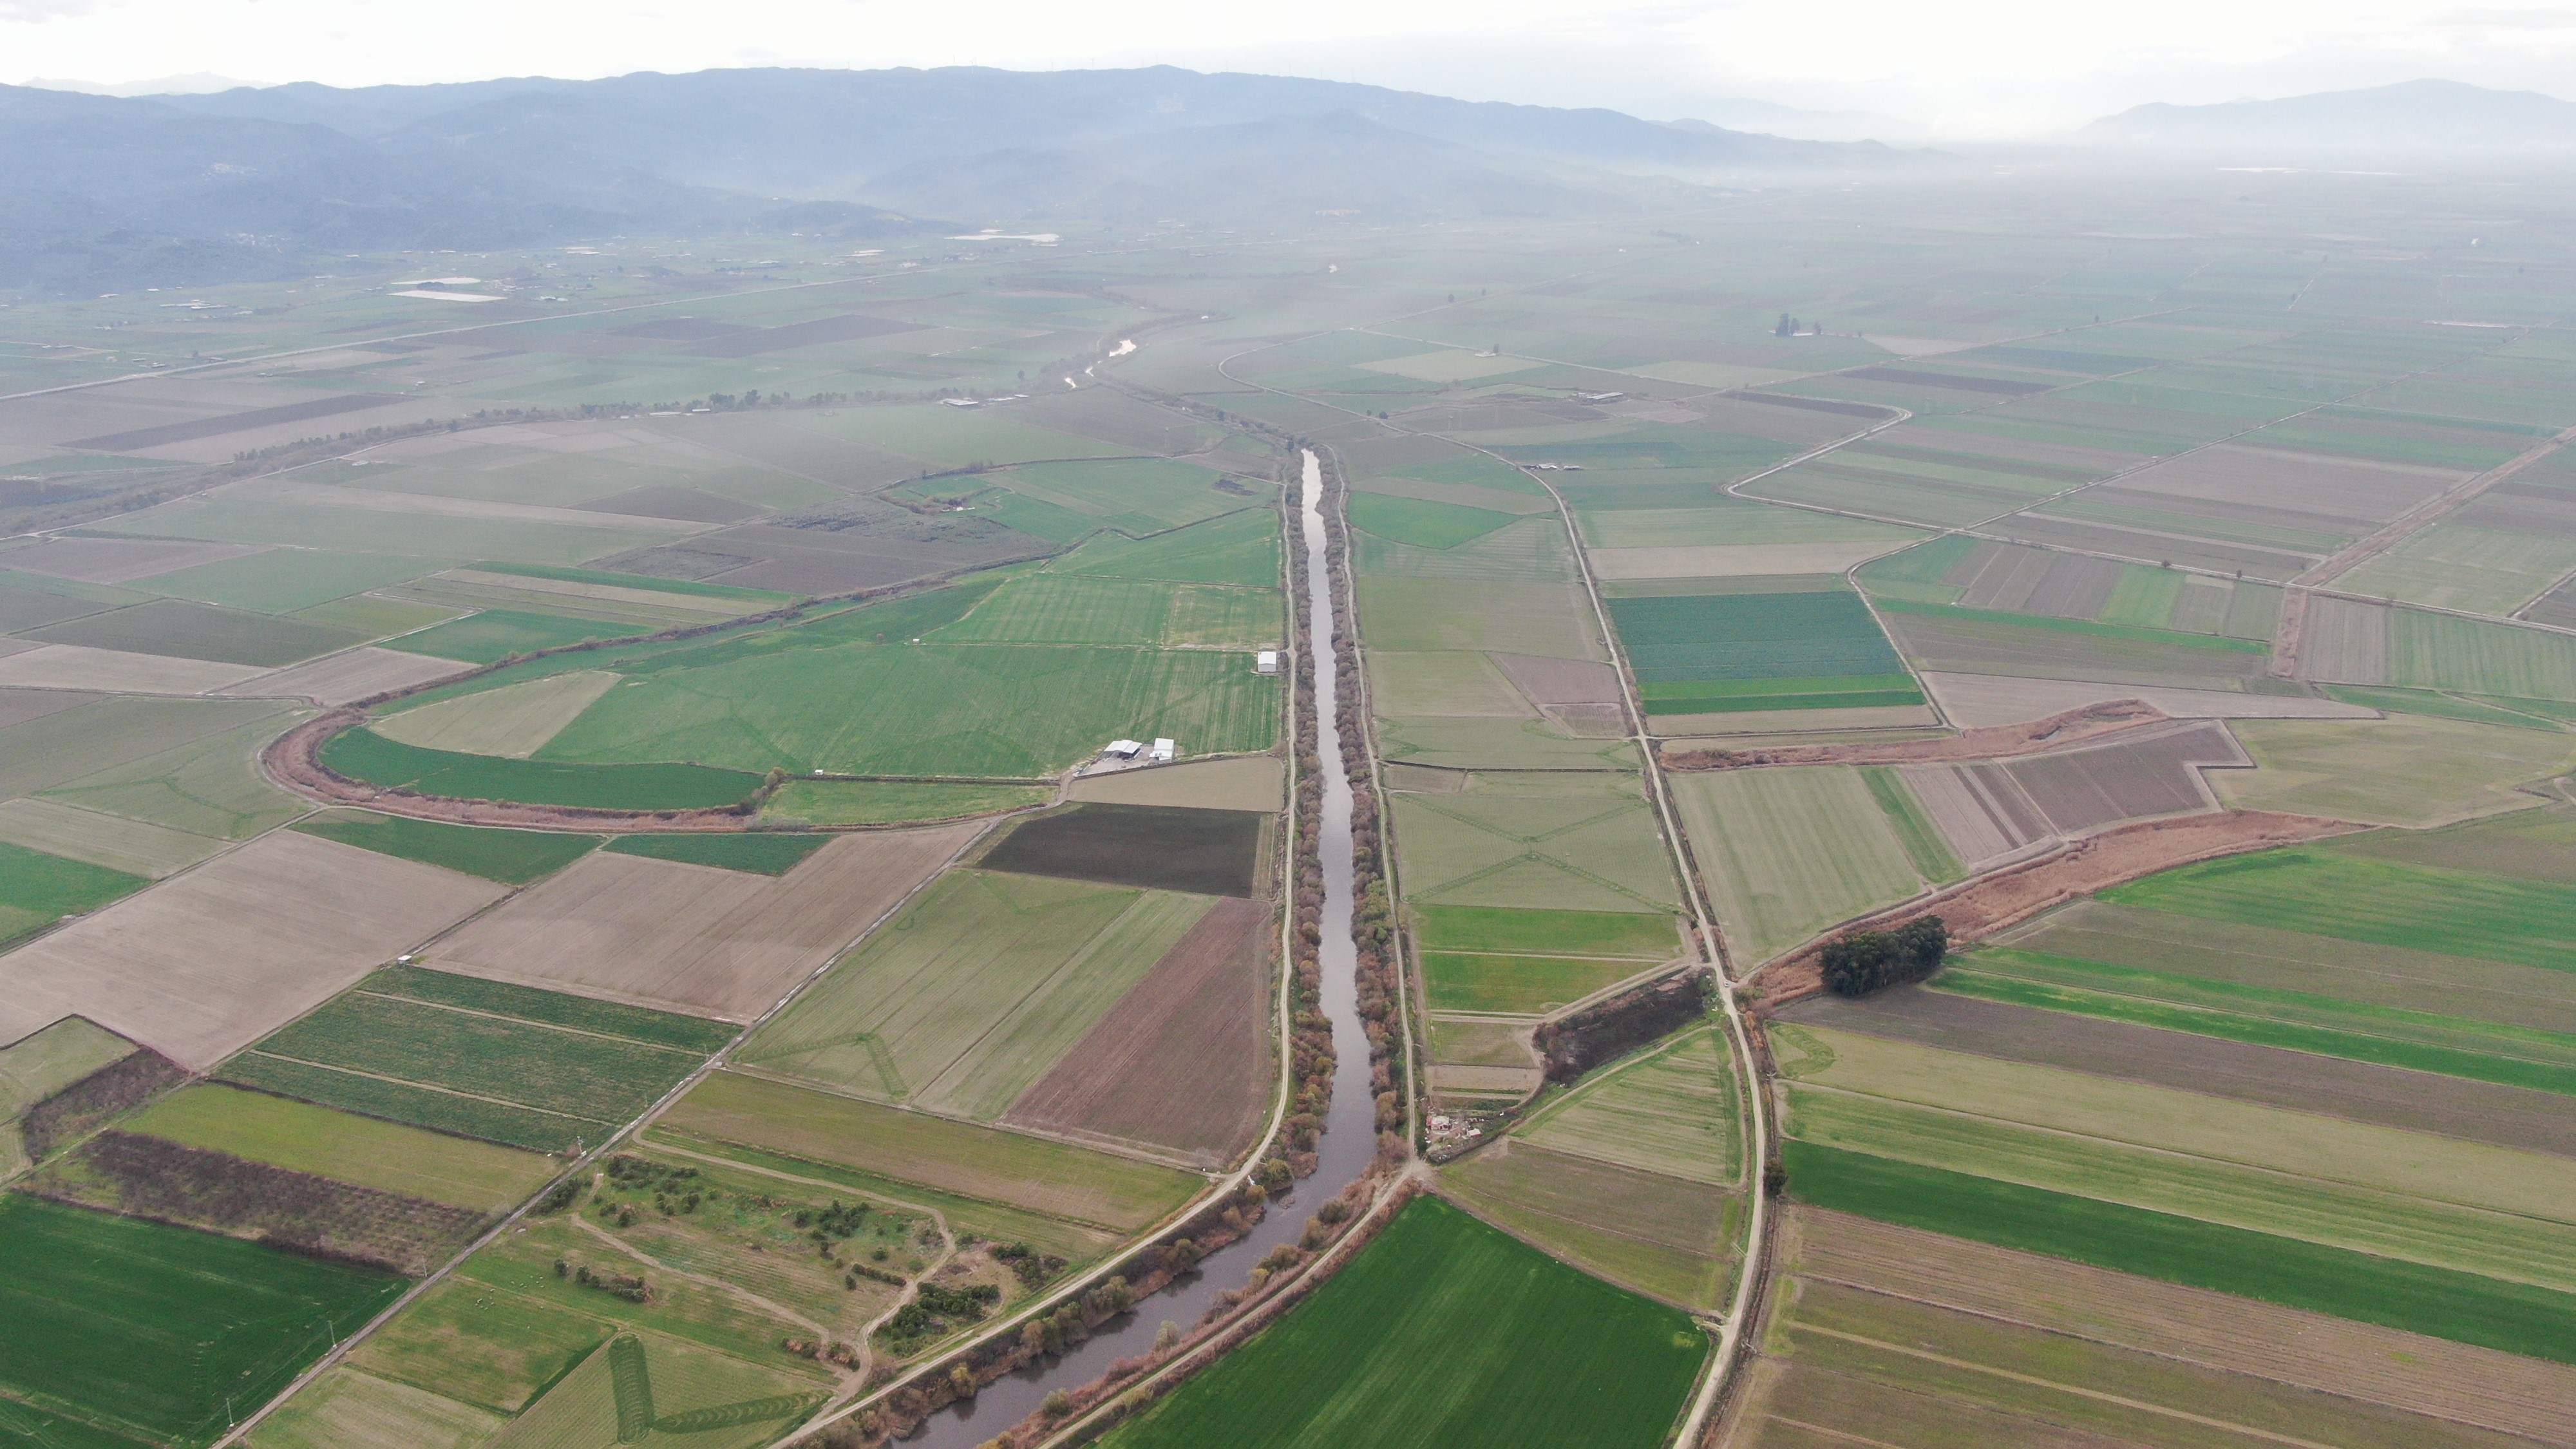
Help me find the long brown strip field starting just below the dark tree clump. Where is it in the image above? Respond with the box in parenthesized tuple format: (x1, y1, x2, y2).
(1783, 985, 2576, 1158)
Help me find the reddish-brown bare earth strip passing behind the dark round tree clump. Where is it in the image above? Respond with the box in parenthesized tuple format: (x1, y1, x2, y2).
(1757, 810, 2362, 1013)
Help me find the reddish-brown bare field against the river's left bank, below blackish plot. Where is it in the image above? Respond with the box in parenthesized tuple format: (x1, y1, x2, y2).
(1002, 900, 1278, 1168)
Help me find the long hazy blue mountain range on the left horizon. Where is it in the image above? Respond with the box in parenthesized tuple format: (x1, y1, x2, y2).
(0, 67, 1914, 289)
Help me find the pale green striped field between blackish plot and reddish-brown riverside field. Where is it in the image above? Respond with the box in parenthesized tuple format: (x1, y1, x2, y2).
(737, 871, 1213, 1122)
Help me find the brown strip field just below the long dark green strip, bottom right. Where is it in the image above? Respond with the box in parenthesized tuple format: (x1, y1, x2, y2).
(1790, 1207, 2576, 1441)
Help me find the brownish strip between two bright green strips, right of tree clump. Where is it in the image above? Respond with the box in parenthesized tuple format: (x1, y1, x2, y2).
(1996, 900, 2576, 1031)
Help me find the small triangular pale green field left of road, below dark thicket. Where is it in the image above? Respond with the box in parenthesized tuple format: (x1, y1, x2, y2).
(1517, 1028, 1744, 1186)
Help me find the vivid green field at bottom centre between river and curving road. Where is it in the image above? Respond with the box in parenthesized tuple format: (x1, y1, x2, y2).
(1105, 1199, 1708, 1449)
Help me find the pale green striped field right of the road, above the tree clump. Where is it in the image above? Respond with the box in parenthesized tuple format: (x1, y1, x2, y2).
(1672, 766, 1924, 961)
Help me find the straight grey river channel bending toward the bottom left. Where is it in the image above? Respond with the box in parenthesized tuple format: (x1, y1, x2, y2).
(904, 454, 1378, 1449)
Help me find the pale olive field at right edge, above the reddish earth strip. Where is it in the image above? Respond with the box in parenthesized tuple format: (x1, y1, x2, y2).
(2208, 714, 2576, 828)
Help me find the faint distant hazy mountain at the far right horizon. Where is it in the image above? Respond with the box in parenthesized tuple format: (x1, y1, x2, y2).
(2079, 80, 2576, 160)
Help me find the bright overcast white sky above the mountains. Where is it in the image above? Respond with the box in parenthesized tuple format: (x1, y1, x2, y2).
(0, 0, 2576, 137)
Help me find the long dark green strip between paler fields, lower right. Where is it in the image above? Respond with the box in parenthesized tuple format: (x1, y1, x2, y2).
(1783, 1142, 2576, 1364)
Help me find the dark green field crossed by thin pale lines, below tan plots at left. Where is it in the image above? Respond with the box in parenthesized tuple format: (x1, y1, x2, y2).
(222, 967, 734, 1153)
